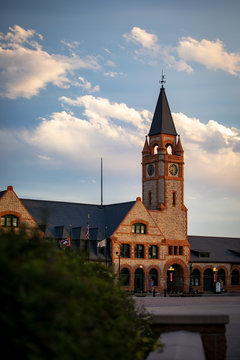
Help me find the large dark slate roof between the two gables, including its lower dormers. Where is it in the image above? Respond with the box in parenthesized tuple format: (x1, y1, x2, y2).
(20, 199, 135, 262)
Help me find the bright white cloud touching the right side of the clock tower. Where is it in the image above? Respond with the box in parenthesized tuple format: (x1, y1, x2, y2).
(173, 113, 240, 188)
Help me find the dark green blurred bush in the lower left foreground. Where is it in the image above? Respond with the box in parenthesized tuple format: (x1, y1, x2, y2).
(0, 231, 158, 360)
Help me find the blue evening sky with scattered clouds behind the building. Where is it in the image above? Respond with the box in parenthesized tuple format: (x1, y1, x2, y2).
(0, 0, 240, 237)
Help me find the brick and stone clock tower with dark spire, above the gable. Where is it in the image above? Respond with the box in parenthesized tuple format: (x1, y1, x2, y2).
(142, 76, 185, 211)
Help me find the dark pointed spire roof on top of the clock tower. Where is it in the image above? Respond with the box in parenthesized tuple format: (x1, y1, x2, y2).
(148, 87, 177, 136)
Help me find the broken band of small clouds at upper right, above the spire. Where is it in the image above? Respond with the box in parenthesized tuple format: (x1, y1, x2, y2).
(123, 26, 240, 76)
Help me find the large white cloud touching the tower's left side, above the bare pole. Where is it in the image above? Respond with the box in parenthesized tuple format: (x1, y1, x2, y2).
(21, 95, 151, 174)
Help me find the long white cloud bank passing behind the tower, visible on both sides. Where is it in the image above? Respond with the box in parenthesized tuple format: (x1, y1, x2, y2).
(1, 91, 240, 191)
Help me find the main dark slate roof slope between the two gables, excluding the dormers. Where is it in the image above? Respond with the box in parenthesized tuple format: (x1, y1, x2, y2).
(20, 199, 135, 240)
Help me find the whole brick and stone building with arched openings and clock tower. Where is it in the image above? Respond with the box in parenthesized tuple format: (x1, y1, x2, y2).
(0, 86, 240, 292)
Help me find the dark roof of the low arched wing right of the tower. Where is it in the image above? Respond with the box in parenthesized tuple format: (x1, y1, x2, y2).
(188, 236, 240, 264)
